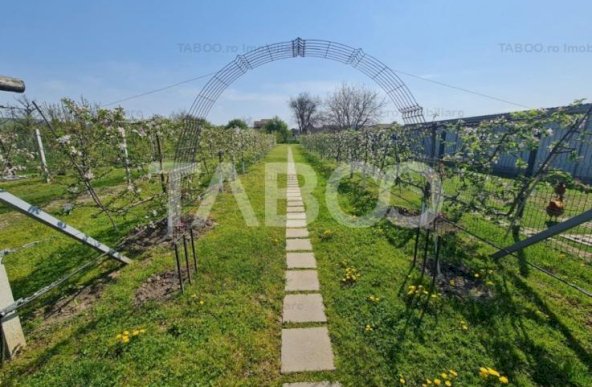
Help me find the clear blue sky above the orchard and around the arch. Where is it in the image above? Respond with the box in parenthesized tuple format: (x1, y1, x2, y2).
(0, 0, 592, 126)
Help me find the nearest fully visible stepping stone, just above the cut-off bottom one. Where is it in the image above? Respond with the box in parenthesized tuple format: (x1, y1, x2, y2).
(281, 327, 335, 374)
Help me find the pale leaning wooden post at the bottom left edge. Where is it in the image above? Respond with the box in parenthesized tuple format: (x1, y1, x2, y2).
(0, 255, 26, 360)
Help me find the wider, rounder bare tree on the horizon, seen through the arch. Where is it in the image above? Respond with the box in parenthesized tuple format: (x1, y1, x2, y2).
(325, 83, 385, 130)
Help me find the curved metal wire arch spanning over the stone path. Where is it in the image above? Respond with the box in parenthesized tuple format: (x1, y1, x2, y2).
(169, 38, 425, 232)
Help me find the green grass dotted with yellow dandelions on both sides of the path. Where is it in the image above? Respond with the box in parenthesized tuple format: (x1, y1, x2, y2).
(0, 145, 592, 386)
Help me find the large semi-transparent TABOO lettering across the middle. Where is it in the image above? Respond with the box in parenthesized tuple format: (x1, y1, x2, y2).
(169, 162, 442, 228)
